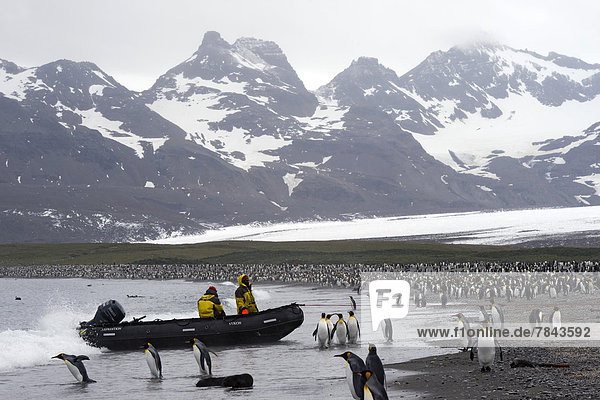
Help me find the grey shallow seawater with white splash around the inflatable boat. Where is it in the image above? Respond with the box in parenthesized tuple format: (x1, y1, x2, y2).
(0, 279, 442, 400)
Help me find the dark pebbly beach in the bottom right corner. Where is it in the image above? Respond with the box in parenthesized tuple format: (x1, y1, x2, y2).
(385, 348, 600, 400)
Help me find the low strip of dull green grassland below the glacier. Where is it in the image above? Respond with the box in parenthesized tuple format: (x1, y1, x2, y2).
(0, 240, 600, 266)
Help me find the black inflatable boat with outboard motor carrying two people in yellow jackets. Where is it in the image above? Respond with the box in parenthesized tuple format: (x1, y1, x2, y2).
(78, 300, 304, 350)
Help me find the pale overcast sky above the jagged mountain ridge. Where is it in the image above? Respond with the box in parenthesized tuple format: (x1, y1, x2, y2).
(0, 0, 600, 90)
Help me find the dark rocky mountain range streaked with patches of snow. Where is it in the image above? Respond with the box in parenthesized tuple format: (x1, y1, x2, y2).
(0, 32, 600, 242)
